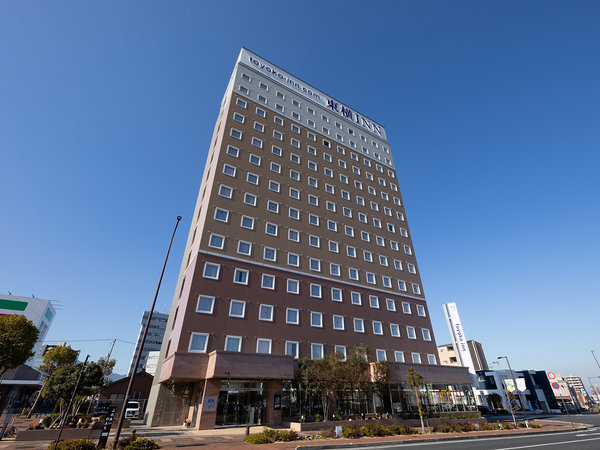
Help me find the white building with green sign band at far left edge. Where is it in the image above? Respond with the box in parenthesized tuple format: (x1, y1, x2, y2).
(0, 295, 56, 368)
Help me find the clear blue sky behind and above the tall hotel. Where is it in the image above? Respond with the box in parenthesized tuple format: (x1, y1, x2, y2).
(0, 1, 600, 384)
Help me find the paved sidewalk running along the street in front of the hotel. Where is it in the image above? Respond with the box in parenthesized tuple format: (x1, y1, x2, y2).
(0, 420, 587, 450)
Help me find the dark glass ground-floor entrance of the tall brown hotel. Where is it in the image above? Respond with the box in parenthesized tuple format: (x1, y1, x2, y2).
(215, 380, 266, 426)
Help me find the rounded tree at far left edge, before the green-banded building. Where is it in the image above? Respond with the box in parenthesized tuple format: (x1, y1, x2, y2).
(0, 314, 39, 377)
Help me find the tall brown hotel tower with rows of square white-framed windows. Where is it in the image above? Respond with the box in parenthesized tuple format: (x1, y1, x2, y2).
(147, 49, 472, 429)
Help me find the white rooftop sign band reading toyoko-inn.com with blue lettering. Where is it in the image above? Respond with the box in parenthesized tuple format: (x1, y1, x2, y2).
(238, 48, 386, 139)
